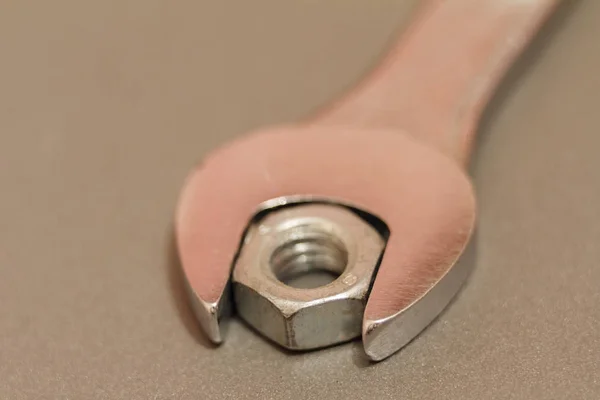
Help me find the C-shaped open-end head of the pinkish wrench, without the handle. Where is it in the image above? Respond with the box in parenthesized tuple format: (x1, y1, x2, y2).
(176, 126, 475, 360)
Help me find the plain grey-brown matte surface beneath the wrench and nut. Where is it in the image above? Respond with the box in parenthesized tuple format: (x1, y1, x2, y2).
(0, 0, 600, 399)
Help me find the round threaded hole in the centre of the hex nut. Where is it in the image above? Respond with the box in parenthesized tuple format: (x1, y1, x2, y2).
(270, 225, 348, 289)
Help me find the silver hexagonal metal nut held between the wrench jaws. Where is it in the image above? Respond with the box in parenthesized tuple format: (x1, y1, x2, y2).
(232, 203, 385, 350)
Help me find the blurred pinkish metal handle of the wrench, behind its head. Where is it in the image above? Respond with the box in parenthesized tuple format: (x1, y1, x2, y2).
(311, 0, 560, 164)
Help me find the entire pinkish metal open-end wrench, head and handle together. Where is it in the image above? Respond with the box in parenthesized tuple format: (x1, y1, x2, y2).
(176, 0, 558, 361)
